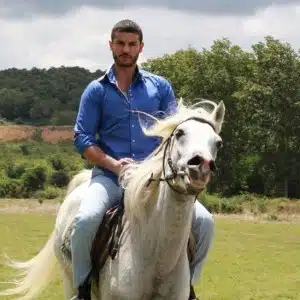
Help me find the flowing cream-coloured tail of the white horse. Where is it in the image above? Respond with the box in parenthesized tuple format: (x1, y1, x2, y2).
(0, 232, 58, 300)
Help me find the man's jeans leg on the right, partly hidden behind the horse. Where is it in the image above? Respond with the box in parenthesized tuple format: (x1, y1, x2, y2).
(190, 201, 215, 284)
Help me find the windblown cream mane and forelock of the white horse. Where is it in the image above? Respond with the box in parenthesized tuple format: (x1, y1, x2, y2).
(119, 99, 218, 219)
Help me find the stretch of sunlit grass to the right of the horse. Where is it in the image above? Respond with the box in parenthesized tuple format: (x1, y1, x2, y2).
(197, 218, 300, 300)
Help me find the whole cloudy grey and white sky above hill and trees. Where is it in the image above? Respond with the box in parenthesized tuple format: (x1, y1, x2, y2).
(0, 0, 300, 71)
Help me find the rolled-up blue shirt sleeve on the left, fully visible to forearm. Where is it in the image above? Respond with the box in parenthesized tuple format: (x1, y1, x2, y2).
(74, 80, 103, 154)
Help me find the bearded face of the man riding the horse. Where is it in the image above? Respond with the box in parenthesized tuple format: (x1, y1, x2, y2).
(109, 32, 144, 68)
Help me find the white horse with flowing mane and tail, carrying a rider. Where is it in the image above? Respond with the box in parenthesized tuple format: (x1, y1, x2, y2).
(2, 100, 225, 300)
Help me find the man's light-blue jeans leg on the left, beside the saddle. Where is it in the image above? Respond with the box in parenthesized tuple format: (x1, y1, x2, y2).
(71, 169, 122, 298)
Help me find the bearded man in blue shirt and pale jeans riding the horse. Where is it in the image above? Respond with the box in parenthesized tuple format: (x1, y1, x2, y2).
(71, 20, 214, 300)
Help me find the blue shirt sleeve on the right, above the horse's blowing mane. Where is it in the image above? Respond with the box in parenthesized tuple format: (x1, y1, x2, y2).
(159, 78, 177, 117)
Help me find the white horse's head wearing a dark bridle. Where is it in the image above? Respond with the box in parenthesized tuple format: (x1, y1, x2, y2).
(163, 101, 225, 195)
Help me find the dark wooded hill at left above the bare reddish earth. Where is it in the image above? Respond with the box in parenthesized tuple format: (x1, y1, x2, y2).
(0, 67, 104, 125)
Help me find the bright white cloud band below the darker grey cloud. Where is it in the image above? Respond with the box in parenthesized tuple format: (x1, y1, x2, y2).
(0, 5, 300, 70)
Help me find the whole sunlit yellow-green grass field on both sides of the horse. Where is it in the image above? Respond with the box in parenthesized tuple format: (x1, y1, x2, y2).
(0, 212, 300, 300)
